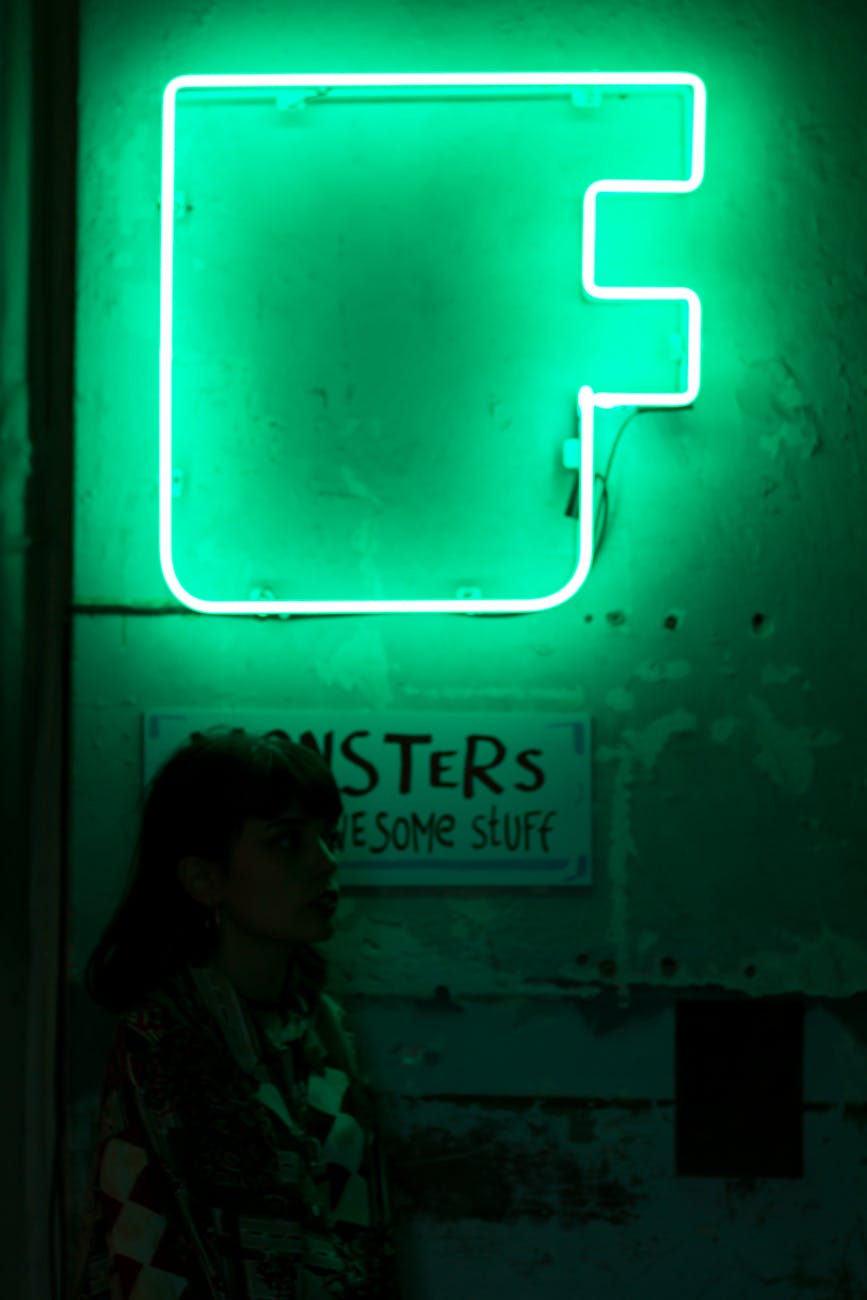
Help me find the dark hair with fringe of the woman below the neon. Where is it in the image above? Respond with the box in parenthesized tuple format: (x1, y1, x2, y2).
(84, 727, 343, 1013)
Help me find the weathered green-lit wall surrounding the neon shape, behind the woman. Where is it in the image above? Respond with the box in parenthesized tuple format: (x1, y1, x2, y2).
(70, 0, 867, 1300)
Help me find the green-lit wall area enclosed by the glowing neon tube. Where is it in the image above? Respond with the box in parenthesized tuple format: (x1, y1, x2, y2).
(161, 74, 706, 612)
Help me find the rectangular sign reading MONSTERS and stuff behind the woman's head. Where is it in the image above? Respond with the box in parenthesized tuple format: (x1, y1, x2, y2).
(144, 709, 591, 888)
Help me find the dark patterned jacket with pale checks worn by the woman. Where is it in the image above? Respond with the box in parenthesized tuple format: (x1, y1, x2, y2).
(71, 965, 400, 1300)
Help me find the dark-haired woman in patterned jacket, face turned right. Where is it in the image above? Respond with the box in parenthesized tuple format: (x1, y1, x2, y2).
(73, 728, 399, 1300)
